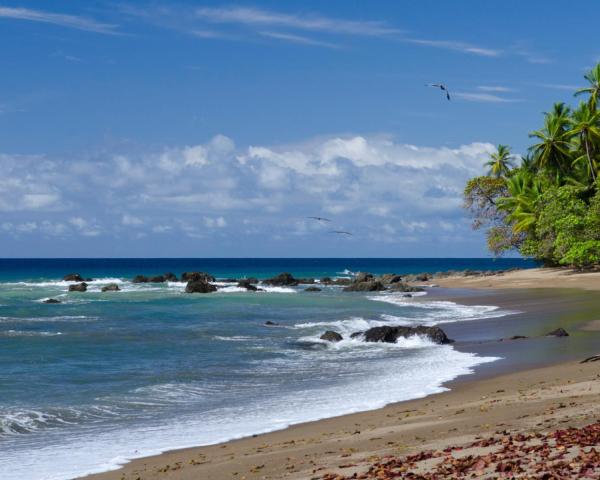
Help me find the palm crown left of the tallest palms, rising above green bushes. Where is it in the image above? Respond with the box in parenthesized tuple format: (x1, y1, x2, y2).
(529, 107, 570, 174)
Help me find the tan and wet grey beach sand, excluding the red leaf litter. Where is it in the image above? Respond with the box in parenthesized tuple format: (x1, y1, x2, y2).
(85, 270, 600, 480)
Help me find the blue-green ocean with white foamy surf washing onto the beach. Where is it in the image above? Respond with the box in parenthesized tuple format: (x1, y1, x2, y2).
(0, 259, 534, 480)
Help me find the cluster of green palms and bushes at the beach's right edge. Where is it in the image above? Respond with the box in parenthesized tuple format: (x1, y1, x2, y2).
(464, 64, 600, 268)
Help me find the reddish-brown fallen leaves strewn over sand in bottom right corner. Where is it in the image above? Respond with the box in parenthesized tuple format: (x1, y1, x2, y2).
(319, 422, 600, 480)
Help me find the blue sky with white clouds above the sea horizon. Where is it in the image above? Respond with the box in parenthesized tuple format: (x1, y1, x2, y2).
(0, 0, 600, 257)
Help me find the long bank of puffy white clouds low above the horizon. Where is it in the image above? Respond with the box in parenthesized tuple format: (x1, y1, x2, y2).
(0, 135, 494, 247)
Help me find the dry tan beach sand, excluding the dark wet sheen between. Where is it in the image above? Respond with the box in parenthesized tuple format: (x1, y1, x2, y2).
(85, 269, 600, 480)
